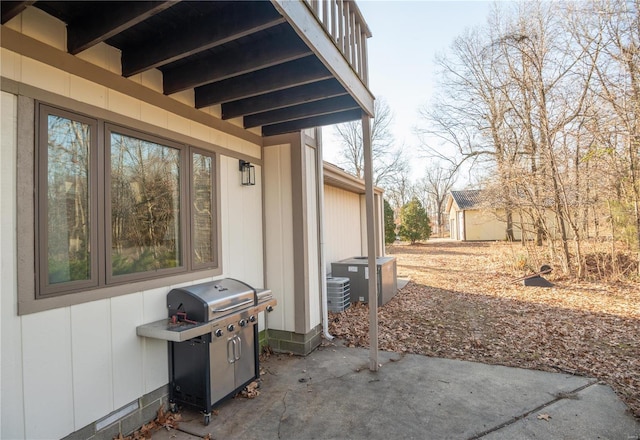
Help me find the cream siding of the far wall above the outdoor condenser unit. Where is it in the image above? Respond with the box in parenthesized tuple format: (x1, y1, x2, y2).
(324, 185, 366, 273)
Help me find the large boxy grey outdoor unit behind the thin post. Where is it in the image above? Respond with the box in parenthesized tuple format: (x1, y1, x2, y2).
(331, 257, 398, 306)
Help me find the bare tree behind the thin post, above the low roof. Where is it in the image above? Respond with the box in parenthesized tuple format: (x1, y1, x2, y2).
(335, 98, 409, 187)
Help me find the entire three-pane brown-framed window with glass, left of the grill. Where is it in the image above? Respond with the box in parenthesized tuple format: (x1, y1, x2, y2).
(37, 105, 217, 298)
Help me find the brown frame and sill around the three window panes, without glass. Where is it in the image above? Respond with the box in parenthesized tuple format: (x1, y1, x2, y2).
(34, 101, 222, 300)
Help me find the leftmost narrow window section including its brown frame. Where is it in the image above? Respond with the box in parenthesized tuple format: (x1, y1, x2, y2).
(39, 108, 97, 293)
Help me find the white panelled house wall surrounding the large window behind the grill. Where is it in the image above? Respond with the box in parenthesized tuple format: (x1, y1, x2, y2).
(0, 8, 264, 439)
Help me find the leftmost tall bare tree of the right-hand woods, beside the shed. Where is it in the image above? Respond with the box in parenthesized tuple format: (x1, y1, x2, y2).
(417, 12, 519, 239)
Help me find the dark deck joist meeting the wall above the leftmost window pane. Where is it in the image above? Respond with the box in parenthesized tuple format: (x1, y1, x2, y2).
(67, 1, 178, 55)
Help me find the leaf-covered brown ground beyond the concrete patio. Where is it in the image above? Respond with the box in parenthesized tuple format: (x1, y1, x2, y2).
(329, 239, 640, 418)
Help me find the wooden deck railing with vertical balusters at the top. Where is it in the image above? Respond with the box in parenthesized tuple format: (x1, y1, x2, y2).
(305, 0, 371, 86)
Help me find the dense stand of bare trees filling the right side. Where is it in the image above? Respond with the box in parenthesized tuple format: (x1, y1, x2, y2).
(420, 0, 640, 277)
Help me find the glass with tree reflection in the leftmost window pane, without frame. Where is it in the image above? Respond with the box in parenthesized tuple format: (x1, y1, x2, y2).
(46, 115, 91, 284)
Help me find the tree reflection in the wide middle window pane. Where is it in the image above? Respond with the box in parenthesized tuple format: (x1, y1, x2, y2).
(111, 132, 182, 275)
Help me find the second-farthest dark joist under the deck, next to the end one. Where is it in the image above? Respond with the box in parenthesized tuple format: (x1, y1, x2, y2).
(244, 95, 359, 128)
